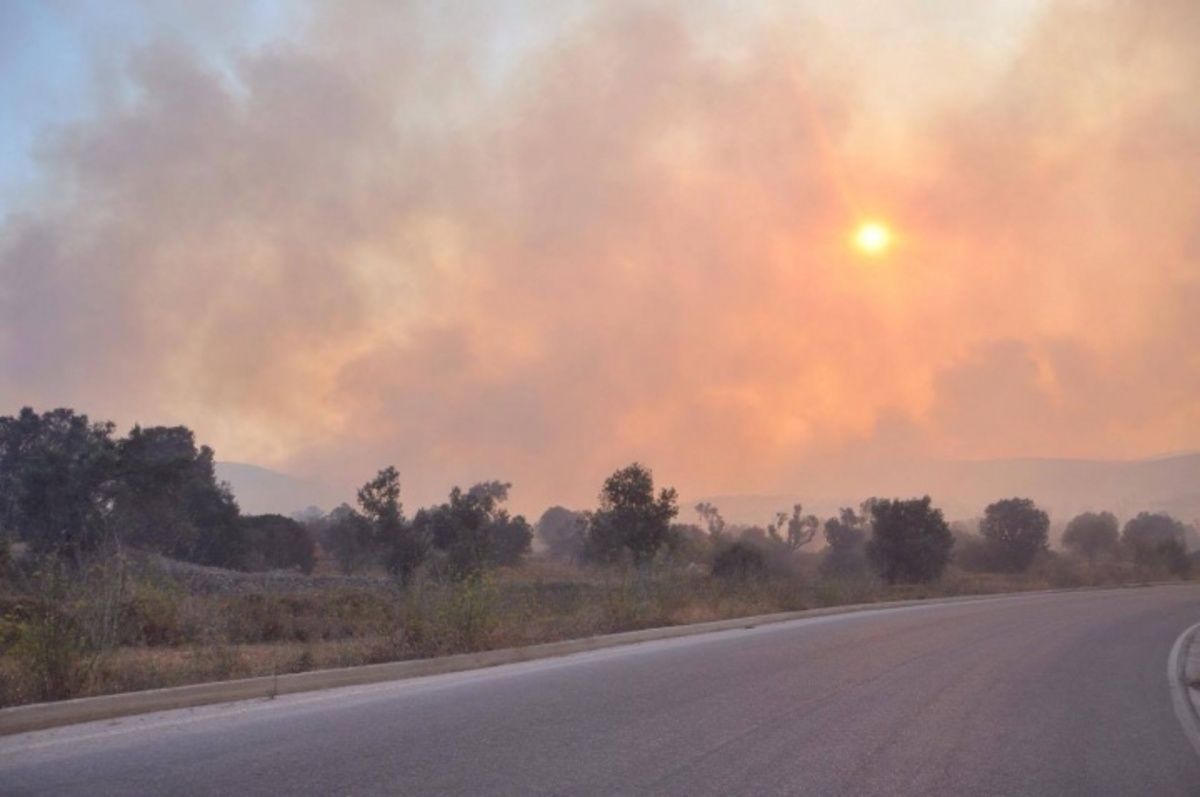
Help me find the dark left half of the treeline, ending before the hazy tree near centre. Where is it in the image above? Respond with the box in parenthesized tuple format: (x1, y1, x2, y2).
(0, 407, 533, 580)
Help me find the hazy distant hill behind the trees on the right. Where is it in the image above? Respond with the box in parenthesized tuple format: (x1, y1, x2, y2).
(696, 454, 1200, 525)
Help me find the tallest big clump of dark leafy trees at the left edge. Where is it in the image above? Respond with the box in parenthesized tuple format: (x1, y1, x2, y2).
(0, 407, 242, 567)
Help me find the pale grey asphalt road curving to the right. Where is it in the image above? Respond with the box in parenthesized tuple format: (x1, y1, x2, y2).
(0, 586, 1200, 797)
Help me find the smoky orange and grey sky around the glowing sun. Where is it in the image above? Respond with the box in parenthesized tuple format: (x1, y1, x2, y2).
(0, 0, 1200, 513)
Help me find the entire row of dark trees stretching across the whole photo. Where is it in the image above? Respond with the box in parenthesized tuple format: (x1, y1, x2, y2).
(0, 408, 1195, 583)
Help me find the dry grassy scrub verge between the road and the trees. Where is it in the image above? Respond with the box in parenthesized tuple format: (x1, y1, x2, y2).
(0, 558, 1185, 706)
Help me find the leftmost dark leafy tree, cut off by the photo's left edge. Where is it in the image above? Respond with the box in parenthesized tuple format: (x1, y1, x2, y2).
(0, 407, 116, 564)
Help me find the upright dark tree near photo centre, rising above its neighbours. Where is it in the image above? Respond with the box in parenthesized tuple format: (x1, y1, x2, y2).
(588, 462, 679, 569)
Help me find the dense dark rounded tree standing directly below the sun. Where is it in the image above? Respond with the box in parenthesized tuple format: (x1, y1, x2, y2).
(866, 496, 954, 583)
